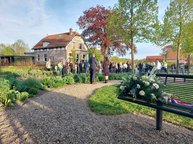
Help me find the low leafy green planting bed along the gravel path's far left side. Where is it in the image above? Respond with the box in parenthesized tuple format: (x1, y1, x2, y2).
(0, 71, 128, 106)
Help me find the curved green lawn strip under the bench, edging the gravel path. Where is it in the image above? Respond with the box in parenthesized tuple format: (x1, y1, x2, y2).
(88, 86, 193, 129)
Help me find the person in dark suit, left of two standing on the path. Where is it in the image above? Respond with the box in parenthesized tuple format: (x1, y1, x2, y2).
(89, 53, 97, 84)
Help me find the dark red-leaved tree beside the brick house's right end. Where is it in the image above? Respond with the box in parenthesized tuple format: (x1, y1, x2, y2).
(77, 5, 128, 55)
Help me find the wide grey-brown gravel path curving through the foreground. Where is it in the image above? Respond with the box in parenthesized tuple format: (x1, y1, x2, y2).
(0, 81, 193, 144)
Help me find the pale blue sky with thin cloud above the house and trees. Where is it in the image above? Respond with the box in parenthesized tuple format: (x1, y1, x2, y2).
(0, 0, 169, 59)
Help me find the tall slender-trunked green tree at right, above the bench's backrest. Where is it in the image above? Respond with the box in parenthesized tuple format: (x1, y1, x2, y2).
(162, 0, 193, 72)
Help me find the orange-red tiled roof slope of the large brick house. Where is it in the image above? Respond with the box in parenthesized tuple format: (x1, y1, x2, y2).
(33, 32, 80, 49)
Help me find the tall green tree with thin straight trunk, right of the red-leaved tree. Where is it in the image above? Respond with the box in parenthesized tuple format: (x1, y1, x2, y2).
(109, 0, 158, 73)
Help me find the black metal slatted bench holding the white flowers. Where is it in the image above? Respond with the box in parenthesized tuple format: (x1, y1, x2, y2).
(118, 74, 193, 130)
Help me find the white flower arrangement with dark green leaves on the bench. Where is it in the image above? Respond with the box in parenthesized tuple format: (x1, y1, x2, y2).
(119, 67, 171, 103)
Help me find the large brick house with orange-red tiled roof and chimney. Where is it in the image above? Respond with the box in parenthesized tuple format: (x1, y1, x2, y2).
(32, 29, 88, 63)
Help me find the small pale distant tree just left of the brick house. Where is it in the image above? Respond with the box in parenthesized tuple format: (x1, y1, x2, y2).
(11, 40, 29, 56)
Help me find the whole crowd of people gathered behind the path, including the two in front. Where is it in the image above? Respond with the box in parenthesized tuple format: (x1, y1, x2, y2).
(46, 54, 190, 83)
